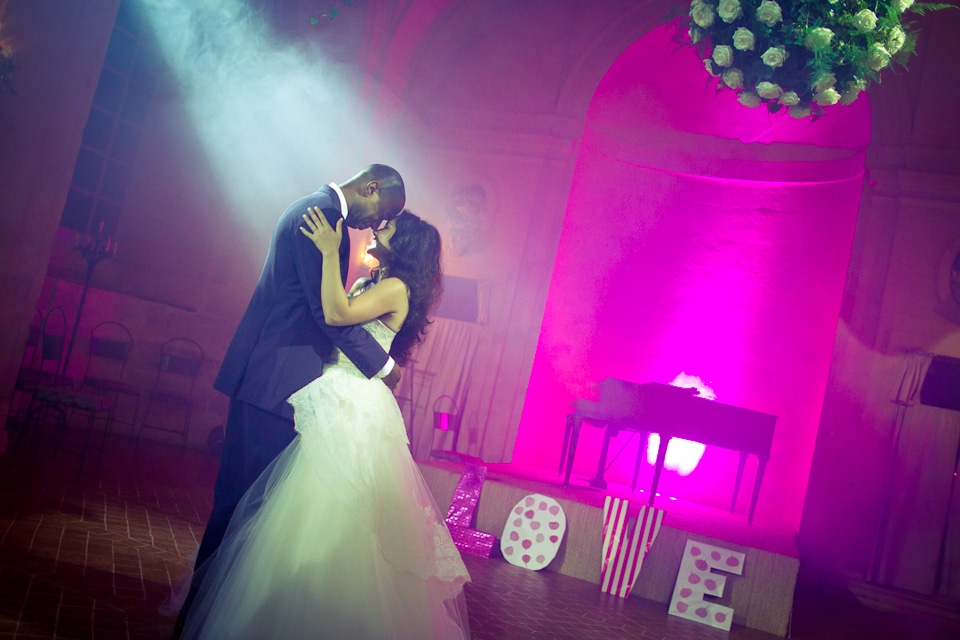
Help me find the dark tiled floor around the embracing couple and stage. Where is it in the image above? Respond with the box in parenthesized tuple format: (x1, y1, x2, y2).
(0, 420, 960, 640)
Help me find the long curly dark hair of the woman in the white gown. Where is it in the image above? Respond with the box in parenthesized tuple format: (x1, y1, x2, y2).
(386, 209, 443, 366)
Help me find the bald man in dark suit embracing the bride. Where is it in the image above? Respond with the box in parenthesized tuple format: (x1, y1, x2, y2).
(175, 164, 406, 634)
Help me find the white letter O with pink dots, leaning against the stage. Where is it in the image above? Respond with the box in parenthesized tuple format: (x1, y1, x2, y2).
(500, 493, 567, 571)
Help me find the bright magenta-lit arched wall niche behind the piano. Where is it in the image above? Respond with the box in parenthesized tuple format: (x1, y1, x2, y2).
(514, 28, 869, 531)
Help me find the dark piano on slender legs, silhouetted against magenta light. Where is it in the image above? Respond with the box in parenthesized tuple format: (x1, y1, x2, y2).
(560, 378, 777, 522)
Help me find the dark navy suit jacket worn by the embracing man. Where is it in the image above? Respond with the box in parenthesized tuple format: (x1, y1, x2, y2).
(213, 186, 388, 419)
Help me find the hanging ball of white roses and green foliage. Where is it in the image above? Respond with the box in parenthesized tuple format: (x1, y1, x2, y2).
(680, 0, 952, 119)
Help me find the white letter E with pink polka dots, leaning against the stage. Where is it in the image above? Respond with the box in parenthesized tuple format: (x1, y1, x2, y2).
(668, 540, 744, 631)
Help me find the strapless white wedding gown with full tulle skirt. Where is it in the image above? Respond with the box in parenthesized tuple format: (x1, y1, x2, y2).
(182, 321, 470, 640)
